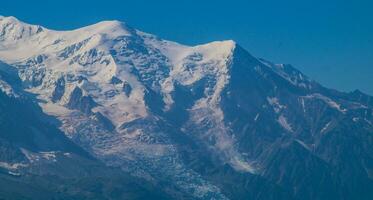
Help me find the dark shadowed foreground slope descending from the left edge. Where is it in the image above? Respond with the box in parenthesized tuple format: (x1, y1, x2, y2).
(0, 61, 168, 199)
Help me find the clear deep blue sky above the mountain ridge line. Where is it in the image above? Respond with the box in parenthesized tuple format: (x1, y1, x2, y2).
(0, 0, 373, 95)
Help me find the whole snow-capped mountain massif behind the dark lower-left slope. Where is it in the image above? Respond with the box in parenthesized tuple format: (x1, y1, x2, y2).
(0, 17, 373, 199)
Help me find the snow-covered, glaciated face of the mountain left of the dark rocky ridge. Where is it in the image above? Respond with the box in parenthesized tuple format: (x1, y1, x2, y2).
(0, 18, 241, 198)
